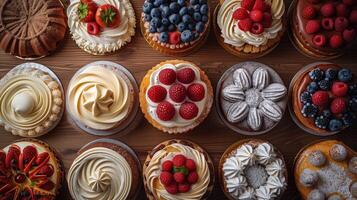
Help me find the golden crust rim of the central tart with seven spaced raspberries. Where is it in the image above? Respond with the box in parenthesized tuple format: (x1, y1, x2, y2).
(139, 60, 213, 134)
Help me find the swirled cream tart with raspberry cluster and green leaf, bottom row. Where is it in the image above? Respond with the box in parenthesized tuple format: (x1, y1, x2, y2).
(143, 140, 214, 200)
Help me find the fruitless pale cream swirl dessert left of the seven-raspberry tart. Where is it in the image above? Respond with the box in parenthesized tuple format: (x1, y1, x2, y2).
(66, 61, 139, 135)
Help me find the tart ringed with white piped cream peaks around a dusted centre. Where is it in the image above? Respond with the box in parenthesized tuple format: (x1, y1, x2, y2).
(219, 139, 288, 200)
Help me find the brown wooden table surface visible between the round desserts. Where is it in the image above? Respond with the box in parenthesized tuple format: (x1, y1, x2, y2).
(0, 0, 357, 199)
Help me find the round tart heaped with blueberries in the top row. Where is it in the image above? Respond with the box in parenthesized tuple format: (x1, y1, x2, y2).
(140, 0, 210, 56)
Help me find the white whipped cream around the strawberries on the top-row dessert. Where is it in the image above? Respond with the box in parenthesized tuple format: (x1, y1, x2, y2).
(67, 0, 136, 55)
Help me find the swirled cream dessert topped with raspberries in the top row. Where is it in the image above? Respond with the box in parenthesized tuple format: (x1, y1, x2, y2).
(214, 0, 285, 58)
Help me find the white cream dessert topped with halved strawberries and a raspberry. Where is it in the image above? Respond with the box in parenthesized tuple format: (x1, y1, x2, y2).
(67, 0, 136, 55)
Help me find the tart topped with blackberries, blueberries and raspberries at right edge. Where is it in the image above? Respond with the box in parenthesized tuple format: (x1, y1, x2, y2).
(289, 62, 357, 136)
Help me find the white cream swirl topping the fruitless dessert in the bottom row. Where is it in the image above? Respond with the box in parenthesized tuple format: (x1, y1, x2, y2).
(67, 147, 132, 200)
